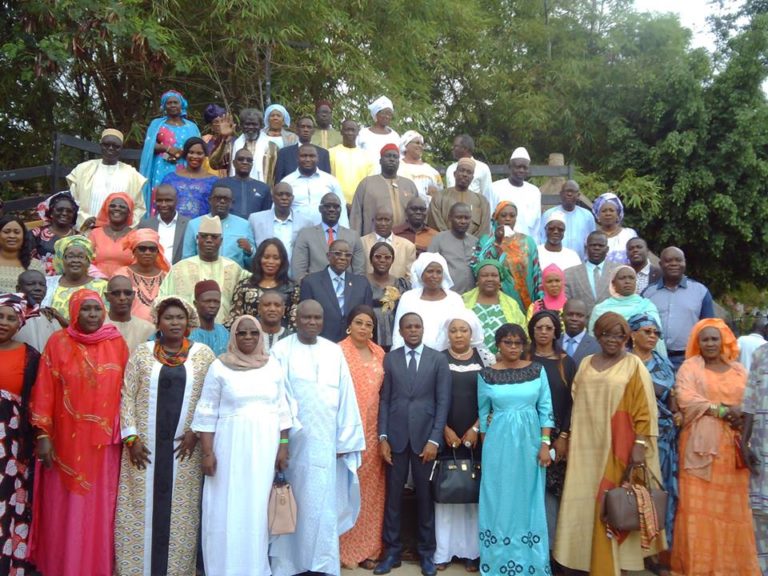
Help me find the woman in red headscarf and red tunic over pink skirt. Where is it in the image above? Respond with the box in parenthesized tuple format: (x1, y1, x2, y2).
(30, 288, 128, 576)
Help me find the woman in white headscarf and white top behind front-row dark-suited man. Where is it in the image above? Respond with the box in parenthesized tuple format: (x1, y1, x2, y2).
(392, 252, 464, 350)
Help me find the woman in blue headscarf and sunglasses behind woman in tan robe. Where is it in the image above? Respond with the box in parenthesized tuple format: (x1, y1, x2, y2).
(628, 314, 682, 560)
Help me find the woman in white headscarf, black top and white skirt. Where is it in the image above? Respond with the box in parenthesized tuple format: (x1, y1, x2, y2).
(434, 308, 496, 572)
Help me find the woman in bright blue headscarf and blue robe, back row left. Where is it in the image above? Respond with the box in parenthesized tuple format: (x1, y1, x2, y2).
(139, 90, 200, 211)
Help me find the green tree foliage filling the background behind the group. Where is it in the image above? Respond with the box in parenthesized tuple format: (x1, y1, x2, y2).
(0, 0, 768, 290)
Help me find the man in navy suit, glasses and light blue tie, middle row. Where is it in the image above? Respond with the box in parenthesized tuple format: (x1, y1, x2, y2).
(300, 240, 373, 342)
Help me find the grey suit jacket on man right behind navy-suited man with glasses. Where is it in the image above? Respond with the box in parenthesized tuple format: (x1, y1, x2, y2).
(291, 224, 365, 282)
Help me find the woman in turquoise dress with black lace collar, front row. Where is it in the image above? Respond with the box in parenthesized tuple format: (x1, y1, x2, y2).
(477, 324, 554, 576)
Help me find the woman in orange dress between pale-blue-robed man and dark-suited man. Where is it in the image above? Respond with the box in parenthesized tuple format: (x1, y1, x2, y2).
(340, 305, 386, 570)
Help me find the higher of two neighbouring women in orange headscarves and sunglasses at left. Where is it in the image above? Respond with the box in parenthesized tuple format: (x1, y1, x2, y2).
(87, 192, 133, 279)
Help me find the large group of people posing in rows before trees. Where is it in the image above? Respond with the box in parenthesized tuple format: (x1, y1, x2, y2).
(0, 91, 768, 576)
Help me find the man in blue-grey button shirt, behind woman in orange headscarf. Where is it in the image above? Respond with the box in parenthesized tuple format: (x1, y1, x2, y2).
(643, 246, 715, 370)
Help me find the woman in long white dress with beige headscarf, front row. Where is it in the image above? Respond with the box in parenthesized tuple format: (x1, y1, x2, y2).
(192, 315, 294, 575)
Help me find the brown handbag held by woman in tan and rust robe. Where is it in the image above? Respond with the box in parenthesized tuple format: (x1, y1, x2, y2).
(601, 464, 669, 532)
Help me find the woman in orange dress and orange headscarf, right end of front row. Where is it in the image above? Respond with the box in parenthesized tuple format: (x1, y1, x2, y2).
(672, 318, 760, 576)
